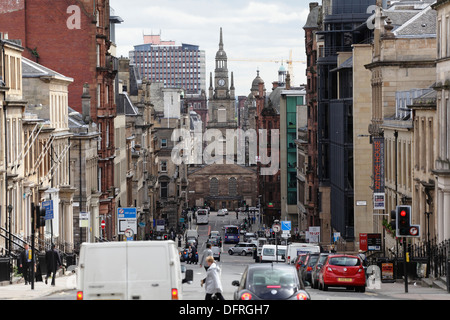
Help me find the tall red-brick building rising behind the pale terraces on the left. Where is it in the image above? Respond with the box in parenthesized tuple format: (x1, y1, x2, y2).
(0, 0, 121, 238)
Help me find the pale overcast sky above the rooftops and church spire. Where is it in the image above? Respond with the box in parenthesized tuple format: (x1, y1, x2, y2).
(110, 0, 312, 96)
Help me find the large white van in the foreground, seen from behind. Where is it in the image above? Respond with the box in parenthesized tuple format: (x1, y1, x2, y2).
(77, 241, 193, 300)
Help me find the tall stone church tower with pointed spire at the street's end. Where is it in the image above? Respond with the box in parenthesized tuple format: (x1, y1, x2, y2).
(207, 28, 237, 131)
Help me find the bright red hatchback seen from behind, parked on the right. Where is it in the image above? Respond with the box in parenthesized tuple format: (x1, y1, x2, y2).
(319, 254, 366, 292)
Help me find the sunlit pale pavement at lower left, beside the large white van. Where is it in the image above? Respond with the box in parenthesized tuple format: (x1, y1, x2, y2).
(0, 272, 77, 300)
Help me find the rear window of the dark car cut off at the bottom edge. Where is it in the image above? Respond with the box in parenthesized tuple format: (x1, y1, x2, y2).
(247, 267, 299, 299)
